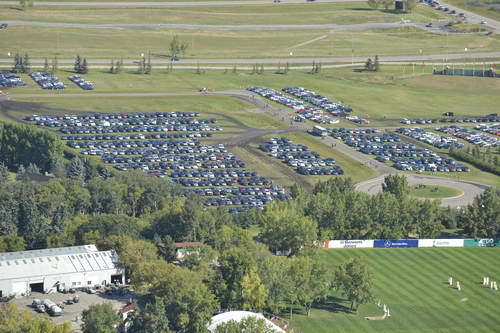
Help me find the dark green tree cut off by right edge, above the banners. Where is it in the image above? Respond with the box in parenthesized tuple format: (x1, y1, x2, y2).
(462, 187, 500, 238)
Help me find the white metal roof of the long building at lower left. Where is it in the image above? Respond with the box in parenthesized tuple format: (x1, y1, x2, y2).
(0, 245, 118, 280)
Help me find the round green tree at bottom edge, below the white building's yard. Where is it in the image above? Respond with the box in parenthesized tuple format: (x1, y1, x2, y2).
(82, 302, 121, 333)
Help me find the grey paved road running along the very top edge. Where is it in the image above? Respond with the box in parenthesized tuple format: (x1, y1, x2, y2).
(0, 0, 366, 7)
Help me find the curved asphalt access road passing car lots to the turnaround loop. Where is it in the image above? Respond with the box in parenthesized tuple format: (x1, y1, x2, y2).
(1, 90, 490, 208)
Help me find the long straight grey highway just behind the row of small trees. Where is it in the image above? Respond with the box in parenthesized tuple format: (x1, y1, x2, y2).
(0, 52, 500, 68)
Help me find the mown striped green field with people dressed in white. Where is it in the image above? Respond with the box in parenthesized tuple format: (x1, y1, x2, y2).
(292, 248, 500, 333)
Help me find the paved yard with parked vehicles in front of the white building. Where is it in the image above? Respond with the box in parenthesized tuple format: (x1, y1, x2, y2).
(11, 292, 131, 332)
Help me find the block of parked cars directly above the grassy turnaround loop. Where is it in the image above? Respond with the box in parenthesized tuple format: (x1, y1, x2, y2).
(331, 128, 470, 172)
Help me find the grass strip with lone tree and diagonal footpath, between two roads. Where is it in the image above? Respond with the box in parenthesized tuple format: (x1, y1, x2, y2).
(0, 26, 500, 62)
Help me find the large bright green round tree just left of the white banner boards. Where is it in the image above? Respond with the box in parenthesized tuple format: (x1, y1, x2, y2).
(259, 203, 317, 256)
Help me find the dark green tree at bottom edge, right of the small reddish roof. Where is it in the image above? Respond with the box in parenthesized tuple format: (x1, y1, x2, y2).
(127, 296, 172, 333)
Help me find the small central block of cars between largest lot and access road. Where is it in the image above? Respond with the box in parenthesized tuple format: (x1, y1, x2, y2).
(259, 137, 344, 175)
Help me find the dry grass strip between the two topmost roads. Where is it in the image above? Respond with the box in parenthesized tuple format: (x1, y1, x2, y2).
(0, 2, 445, 25)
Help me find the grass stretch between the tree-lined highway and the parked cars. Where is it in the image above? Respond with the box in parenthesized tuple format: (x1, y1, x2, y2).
(6, 66, 500, 122)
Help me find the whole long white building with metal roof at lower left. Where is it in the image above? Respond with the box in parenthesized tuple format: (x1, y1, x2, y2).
(0, 245, 124, 296)
